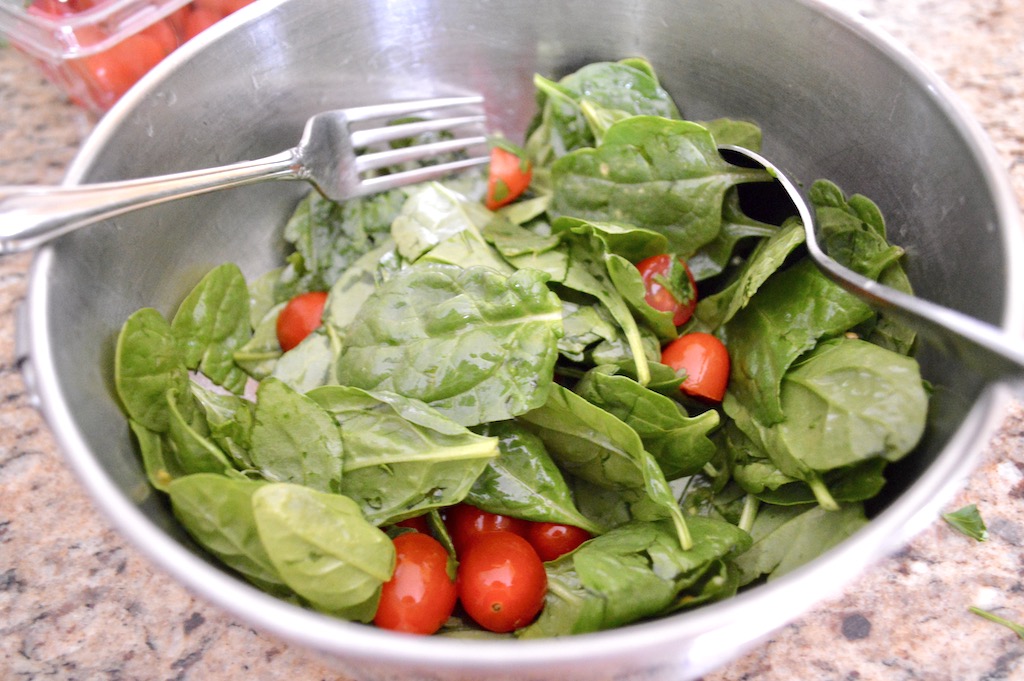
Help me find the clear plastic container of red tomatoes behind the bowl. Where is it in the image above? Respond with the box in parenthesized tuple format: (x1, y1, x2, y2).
(0, 0, 253, 114)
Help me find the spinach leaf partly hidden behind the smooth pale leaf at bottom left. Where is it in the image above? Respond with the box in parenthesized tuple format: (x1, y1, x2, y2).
(167, 473, 288, 594)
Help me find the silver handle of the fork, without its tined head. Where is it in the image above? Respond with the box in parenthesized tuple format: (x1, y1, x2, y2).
(0, 150, 301, 255)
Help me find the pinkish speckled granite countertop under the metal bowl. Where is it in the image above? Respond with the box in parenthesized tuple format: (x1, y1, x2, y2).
(0, 0, 1024, 681)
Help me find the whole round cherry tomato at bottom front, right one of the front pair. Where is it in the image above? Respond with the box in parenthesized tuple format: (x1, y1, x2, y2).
(458, 531, 548, 633)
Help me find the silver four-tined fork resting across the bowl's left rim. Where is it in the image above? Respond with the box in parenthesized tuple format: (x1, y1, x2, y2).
(0, 95, 487, 254)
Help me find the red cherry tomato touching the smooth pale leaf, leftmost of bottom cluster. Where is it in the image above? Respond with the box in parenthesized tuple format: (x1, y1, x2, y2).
(374, 533, 458, 634)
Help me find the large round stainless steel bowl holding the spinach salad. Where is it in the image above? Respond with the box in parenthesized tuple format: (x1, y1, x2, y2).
(23, 0, 1024, 681)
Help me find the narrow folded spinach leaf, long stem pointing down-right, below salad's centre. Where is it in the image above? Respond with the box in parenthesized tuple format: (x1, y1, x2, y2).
(519, 385, 692, 548)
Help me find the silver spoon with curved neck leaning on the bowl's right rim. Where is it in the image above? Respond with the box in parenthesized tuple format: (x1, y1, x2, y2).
(719, 144, 1024, 381)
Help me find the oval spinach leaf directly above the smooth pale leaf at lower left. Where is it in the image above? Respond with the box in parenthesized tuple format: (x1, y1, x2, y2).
(250, 379, 343, 493)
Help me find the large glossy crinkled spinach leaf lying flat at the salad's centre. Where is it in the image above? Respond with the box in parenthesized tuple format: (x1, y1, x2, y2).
(337, 263, 562, 426)
